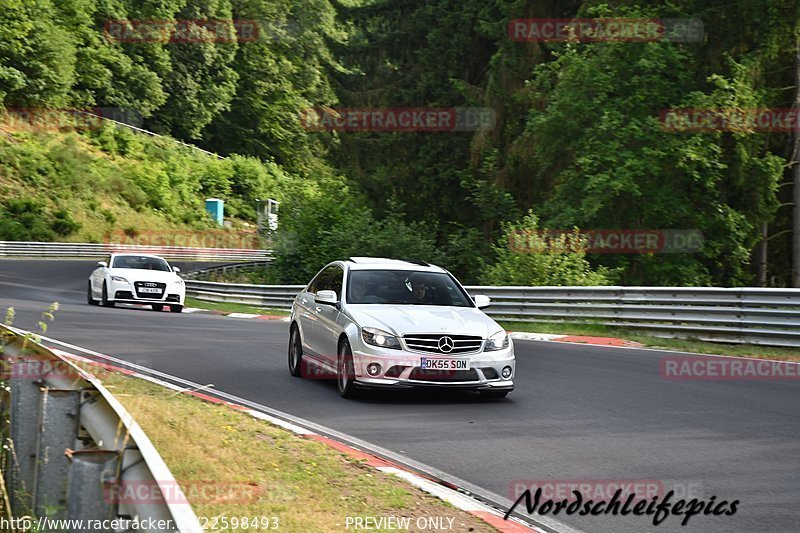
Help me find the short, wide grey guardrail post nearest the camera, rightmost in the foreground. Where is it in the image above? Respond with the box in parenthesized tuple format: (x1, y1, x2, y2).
(67, 450, 119, 533)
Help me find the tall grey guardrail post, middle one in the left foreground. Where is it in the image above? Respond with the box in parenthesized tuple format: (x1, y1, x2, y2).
(33, 388, 80, 518)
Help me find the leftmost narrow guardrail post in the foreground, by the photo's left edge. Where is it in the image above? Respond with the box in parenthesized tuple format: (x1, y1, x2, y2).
(9, 361, 41, 516)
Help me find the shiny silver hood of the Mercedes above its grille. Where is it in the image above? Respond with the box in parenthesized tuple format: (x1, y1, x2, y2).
(348, 304, 501, 338)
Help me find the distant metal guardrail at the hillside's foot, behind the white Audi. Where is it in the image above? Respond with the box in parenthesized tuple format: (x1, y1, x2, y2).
(0, 241, 272, 261)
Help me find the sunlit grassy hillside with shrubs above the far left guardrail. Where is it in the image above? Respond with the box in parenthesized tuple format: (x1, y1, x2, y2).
(0, 126, 288, 242)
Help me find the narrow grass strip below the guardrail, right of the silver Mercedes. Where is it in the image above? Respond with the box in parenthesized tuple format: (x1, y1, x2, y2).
(500, 322, 800, 361)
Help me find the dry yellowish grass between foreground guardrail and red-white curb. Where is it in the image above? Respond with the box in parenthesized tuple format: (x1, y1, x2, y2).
(99, 374, 495, 532)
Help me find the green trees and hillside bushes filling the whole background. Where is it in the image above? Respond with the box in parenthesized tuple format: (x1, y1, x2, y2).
(0, 0, 800, 285)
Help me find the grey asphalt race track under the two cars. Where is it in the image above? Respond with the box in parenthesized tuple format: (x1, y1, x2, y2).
(0, 260, 800, 533)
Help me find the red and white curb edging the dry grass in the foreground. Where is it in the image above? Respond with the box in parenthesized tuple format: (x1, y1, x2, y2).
(50, 347, 543, 533)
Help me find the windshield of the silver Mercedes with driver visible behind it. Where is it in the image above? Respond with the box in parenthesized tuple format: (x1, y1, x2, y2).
(347, 270, 473, 307)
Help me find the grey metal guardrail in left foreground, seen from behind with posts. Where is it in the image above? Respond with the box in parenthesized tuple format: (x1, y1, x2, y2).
(0, 324, 202, 533)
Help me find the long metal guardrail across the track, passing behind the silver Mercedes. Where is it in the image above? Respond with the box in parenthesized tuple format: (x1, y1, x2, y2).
(186, 280, 800, 347)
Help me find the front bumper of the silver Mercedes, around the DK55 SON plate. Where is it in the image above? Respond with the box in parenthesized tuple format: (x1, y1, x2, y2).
(353, 339, 516, 390)
